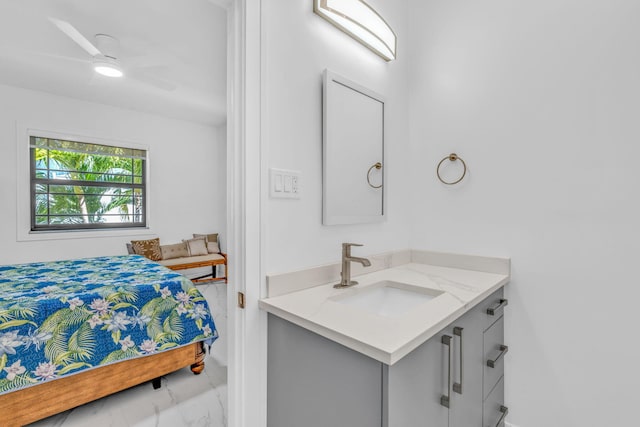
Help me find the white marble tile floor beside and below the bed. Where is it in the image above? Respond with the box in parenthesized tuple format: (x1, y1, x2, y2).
(29, 282, 228, 427)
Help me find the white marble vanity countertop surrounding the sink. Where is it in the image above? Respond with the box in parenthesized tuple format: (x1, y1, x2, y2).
(260, 251, 510, 365)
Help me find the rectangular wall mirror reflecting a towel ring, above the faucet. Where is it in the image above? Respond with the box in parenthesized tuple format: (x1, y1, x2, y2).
(322, 70, 385, 225)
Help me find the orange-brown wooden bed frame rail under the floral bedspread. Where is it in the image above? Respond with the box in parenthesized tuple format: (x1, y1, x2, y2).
(0, 342, 205, 427)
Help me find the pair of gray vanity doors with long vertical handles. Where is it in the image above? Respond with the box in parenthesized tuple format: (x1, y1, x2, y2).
(382, 308, 483, 427)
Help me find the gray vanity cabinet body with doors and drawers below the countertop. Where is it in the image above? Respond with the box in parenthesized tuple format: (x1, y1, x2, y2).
(267, 289, 506, 427)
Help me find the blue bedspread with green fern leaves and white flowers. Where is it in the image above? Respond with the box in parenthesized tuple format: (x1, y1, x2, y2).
(0, 255, 218, 394)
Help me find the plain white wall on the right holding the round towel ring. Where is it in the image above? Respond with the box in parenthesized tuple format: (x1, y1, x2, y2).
(408, 0, 640, 427)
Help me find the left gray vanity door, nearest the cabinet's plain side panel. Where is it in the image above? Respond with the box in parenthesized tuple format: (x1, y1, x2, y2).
(383, 329, 453, 427)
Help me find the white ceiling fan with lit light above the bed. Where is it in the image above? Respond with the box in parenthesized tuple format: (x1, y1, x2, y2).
(49, 17, 176, 91)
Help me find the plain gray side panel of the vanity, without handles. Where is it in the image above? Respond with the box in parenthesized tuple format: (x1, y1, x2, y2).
(267, 315, 382, 427)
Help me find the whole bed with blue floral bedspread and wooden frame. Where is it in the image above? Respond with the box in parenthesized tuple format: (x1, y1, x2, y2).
(0, 255, 218, 427)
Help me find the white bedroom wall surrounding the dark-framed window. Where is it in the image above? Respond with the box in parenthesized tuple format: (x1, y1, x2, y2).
(0, 85, 226, 264)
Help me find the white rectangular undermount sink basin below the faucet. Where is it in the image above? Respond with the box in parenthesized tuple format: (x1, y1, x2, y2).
(331, 280, 443, 317)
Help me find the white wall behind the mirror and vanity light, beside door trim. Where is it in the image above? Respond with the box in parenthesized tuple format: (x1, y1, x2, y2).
(262, 0, 409, 273)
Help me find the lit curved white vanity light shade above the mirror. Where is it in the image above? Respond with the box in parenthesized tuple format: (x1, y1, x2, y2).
(313, 0, 396, 61)
